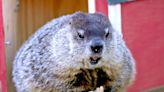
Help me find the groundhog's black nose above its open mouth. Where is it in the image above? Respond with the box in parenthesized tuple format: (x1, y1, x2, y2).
(91, 42, 103, 54)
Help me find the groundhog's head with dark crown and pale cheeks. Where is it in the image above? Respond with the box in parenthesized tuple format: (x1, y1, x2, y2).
(53, 12, 120, 68)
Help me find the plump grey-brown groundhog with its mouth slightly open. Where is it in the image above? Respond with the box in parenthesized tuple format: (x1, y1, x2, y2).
(13, 12, 135, 92)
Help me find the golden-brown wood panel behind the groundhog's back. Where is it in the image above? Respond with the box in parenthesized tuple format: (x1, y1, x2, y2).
(18, 0, 88, 44)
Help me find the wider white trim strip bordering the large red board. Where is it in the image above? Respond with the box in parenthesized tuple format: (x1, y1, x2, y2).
(108, 4, 122, 36)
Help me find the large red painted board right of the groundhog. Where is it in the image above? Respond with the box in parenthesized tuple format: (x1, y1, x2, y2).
(122, 0, 164, 92)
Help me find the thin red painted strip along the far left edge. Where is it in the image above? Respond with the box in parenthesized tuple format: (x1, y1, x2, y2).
(0, 0, 7, 92)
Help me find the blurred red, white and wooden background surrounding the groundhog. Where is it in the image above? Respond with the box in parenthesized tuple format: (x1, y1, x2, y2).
(0, 0, 164, 92)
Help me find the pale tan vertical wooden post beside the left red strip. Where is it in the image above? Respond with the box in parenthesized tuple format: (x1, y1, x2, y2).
(2, 0, 18, 92)
